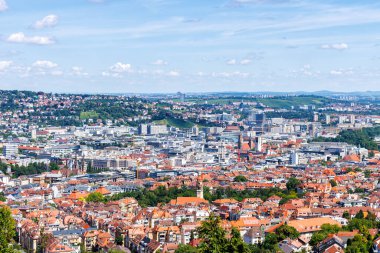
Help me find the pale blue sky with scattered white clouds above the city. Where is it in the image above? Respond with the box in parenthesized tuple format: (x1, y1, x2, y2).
(0, 0, 380, 93)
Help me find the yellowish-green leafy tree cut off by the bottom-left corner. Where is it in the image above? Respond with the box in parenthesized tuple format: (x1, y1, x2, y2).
(0, 206, 16, 253)
